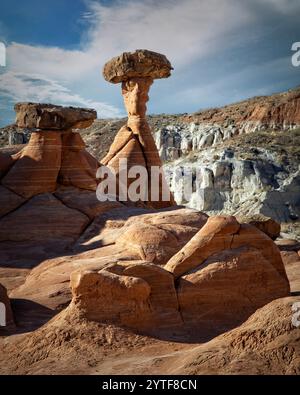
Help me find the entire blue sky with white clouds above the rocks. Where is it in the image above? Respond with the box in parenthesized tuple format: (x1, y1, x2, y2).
(0, 0, 300, 126)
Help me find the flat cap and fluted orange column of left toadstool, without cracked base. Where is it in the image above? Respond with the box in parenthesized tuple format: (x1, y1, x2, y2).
(1, 103, 99, 199)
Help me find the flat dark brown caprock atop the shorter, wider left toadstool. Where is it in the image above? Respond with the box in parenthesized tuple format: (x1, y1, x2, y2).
(15, 103, 97, 130)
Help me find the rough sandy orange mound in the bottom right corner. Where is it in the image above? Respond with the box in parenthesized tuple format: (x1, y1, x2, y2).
(166, 296, 300, 375)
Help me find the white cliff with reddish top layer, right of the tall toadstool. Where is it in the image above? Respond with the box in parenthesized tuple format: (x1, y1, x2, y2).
(155, 88, 300, 226)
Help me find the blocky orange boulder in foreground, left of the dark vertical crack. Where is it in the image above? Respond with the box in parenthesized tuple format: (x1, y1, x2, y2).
(70, 262, 182, 334)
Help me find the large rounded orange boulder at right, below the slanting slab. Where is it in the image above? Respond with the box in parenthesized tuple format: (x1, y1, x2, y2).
(177, 246, 289, 331)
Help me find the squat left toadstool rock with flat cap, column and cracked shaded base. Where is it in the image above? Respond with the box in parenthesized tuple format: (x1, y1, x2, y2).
(0, 103, 121, 248)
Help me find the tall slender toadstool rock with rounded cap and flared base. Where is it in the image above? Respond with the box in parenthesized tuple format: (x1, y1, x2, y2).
(101, 49, 175, 208)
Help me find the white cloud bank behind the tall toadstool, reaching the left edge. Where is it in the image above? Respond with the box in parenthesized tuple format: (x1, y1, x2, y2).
(0, 0, 258, 122)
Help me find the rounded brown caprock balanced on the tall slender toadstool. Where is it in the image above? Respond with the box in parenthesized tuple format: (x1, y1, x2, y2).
(103, 49, 173, 84)
